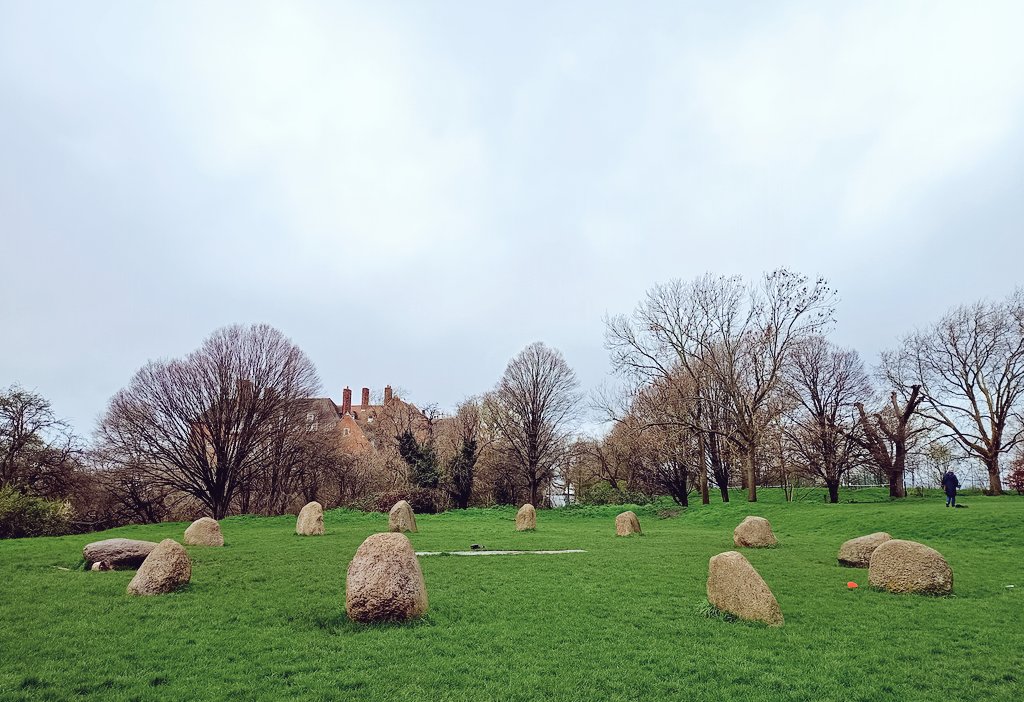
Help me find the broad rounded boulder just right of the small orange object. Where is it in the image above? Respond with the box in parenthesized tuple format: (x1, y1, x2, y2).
(867, 538, 953, 595)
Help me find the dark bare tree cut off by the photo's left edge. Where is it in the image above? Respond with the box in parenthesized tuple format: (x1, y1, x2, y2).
(0, 386, 80, 497)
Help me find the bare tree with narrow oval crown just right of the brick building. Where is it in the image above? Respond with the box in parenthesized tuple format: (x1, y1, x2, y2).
(485, 342, 582, 504)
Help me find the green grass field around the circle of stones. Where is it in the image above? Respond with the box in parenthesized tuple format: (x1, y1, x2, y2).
(0, 490, 1024, 702)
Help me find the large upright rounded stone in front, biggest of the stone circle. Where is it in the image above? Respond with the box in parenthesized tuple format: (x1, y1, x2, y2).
(345, 532, 427, 622)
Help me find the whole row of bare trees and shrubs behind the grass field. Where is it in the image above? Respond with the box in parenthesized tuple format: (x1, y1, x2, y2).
(0, 269, 1024, 528)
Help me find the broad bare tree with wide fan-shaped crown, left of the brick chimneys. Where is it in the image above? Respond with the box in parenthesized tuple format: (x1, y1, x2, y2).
(98, 324, 319, 519)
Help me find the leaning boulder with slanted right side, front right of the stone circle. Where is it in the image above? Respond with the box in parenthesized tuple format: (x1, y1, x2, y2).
(708, 551, 783, 626)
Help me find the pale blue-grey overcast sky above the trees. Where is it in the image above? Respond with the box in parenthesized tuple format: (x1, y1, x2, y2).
(0, 0, 1024, 435)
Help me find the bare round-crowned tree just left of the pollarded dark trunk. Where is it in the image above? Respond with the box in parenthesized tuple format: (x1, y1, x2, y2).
(782, 336, 871, 502)
